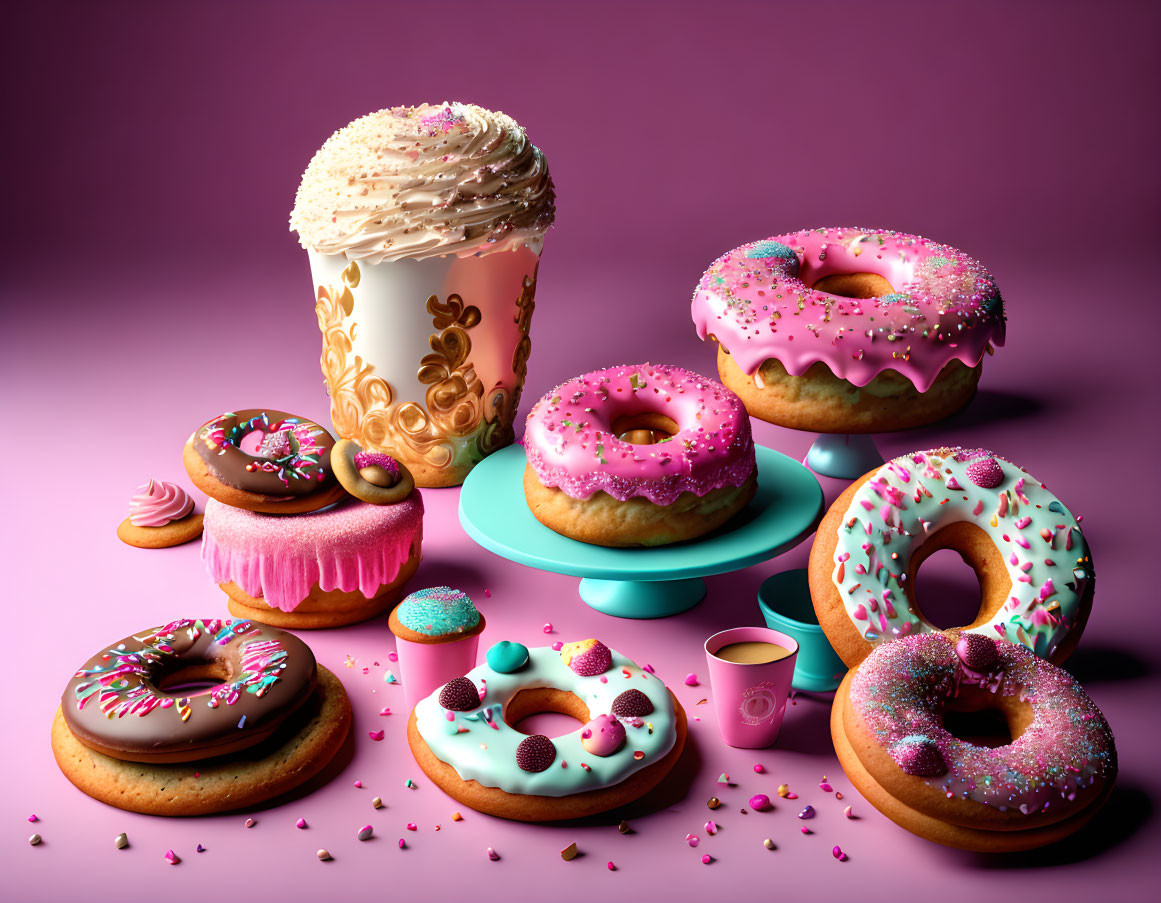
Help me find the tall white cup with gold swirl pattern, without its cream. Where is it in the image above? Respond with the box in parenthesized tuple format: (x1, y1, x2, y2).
(308, 237, 542, 486)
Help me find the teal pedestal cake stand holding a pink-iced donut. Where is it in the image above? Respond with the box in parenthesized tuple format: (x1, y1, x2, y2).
(460, 446, 823, 617)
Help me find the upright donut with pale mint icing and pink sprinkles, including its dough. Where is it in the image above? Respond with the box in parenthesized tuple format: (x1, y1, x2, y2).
(809, 448, 1095, 667)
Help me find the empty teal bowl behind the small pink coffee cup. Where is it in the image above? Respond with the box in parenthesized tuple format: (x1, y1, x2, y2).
(758, 568, 846, 693)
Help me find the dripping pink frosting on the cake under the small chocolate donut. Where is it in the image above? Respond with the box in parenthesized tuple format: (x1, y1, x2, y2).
(202, 492, 424, 612)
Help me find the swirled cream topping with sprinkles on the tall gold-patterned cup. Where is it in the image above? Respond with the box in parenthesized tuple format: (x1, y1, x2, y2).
(290, 103, 556, 263)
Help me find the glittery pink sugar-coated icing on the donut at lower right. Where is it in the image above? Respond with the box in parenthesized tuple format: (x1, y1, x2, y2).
(850, 634, 1117, 815)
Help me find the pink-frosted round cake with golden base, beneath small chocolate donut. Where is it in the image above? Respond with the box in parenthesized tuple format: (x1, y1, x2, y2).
(202, 492, 424, 627)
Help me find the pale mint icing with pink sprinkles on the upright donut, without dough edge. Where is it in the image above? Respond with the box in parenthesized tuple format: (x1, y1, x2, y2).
(832, 448, 1093, 658)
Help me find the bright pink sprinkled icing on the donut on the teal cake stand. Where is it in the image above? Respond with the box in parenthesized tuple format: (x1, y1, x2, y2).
(524, 363, 756, 505)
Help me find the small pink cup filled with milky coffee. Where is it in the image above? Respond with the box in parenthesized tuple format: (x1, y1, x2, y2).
(706, 627, 798, 750)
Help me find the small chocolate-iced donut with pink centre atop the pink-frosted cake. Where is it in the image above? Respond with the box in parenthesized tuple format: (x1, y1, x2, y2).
(181, 409, 346, 514)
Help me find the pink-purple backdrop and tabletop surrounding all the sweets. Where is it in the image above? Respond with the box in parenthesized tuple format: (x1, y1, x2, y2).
(0, 1, 1161, 902)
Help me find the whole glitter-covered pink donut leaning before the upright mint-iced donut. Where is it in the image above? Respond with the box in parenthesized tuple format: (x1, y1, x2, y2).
(830, 634, 1117, 852)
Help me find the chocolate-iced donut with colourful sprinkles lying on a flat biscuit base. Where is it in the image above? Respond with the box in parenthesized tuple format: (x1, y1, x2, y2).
(62, 619, 318, 764)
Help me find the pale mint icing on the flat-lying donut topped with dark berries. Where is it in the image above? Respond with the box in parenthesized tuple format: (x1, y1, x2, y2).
(416, 646, 677, 796)
